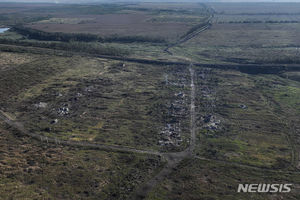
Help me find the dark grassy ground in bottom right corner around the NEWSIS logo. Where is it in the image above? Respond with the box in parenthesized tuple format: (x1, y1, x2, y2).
(146, 159, 300, 200)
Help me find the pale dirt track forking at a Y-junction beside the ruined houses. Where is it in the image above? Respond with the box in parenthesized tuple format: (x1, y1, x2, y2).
(0, 64, 196, 200)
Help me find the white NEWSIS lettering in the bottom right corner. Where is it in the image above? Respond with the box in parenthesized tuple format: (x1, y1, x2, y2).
(237, 183, 293, 193)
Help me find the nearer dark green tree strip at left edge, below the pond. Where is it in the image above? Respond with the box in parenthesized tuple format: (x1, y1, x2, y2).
(0, 38, 129, 56)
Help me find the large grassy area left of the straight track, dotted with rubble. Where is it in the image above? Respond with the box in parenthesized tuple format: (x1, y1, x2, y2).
(2, 51, 189, 150)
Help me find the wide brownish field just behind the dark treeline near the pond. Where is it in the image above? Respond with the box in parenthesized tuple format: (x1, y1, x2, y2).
(29, 13, 191, 39)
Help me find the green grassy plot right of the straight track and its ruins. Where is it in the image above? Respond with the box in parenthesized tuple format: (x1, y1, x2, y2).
(196, 71, 298, 168)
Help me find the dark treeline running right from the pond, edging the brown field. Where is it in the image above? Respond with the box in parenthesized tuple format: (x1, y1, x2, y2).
(12, 26, 166, 43)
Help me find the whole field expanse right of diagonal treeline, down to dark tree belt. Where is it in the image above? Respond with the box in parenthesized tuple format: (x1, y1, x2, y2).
(170, 23, 299, 64)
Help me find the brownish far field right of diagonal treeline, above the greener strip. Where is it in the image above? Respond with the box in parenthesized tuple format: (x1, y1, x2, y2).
(186, 24, 300, 47)
